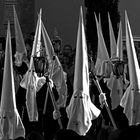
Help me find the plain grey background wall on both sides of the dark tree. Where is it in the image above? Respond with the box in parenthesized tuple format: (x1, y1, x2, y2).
(36, 0, 140, 47)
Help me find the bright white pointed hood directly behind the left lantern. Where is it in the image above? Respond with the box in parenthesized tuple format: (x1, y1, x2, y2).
(20, 9, 42, 121)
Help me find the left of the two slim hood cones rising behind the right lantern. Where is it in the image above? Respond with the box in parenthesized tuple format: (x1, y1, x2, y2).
(108, 13, 117, 58)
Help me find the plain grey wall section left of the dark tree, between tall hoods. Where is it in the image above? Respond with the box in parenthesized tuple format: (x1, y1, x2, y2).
(35, 0, 83, 47)
